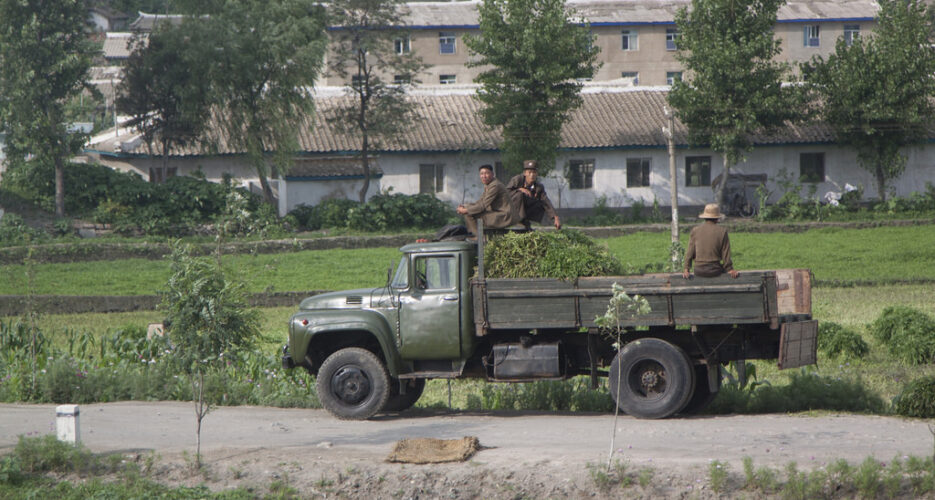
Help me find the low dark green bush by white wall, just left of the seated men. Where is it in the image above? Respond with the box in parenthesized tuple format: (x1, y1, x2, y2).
(347, 192, 454, 231)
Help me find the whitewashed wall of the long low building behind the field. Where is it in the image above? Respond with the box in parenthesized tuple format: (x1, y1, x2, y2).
(101, 144, 935, 219)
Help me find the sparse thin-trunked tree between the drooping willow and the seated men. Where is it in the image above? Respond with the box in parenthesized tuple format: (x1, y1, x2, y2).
(328, 0, 425, 203)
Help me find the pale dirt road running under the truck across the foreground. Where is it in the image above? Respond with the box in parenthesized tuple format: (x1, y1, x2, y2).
(0, 402, 933, 498)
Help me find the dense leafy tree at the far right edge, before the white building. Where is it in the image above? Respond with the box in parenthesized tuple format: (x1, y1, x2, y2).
(802, 0, 935, 200)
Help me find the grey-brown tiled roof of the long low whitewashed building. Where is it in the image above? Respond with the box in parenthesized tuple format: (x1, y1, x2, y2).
(86, 87, 833, 156)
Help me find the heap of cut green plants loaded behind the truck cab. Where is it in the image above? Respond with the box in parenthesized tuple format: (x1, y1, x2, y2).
(484, 229, 623, 279)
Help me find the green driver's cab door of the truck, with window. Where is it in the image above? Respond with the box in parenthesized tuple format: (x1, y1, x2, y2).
(399, 254, 462, 359)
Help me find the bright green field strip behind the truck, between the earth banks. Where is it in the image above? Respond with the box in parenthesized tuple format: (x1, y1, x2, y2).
(0, 226, 935, 295)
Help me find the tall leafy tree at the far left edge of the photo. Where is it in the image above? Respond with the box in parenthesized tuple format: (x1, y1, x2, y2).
(0, 0, 94, 217)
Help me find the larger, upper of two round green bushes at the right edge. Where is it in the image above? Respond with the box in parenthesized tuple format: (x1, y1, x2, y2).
(870, 306, 935, 365)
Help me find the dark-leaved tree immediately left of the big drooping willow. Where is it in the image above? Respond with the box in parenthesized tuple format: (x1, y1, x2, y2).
(117, 20, 209, 181)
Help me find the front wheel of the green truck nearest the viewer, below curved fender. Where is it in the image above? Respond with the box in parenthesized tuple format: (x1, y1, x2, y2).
(315, 347, 390, 420)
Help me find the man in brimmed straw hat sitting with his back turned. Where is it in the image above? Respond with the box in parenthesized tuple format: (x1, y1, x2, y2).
(682, 203, 740, 278)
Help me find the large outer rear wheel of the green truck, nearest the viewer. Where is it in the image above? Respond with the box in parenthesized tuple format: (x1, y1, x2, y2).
(609, 338, 695, 418)
